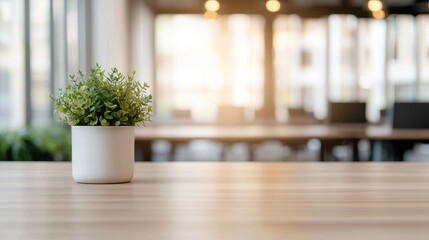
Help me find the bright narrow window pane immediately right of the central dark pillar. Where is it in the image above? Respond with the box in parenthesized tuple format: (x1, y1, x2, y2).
(274, 15, 326, 120)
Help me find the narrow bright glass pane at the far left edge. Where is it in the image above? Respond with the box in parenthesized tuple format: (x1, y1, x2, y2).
(0, 0, 25, 129)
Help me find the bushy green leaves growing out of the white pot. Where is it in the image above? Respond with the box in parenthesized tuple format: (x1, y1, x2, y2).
(52, 64, 152, 126)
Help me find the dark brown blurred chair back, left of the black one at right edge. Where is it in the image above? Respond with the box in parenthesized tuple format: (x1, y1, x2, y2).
(328, 102, 367, 123)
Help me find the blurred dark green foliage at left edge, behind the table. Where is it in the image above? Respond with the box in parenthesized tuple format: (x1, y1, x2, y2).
(0, 126, 71, 161)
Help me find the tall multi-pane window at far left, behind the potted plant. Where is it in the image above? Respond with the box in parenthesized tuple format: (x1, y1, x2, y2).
(0, 0, 78, 129)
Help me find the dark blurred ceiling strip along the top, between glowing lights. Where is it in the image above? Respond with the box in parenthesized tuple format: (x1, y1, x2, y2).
(144, 0, 429, 17)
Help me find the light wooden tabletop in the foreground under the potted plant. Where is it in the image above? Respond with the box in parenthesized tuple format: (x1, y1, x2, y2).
(0, 162, 429, 240)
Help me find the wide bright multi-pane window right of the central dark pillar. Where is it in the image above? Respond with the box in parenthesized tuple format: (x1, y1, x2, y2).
(274, 15, 386, 121)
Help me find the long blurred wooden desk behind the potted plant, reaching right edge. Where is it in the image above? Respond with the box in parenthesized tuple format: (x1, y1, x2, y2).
(136, 124, 429, 161)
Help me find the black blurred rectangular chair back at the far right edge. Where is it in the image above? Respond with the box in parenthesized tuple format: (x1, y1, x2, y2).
(392, 102, 429, 128)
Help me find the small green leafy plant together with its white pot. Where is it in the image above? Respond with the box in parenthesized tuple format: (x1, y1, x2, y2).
(52, 64, 152, 183)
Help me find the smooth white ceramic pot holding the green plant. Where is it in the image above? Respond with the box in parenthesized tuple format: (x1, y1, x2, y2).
(72, 126, 134, 183)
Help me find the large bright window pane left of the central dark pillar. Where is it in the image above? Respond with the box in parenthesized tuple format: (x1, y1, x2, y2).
(156, 15, 264, 122)
